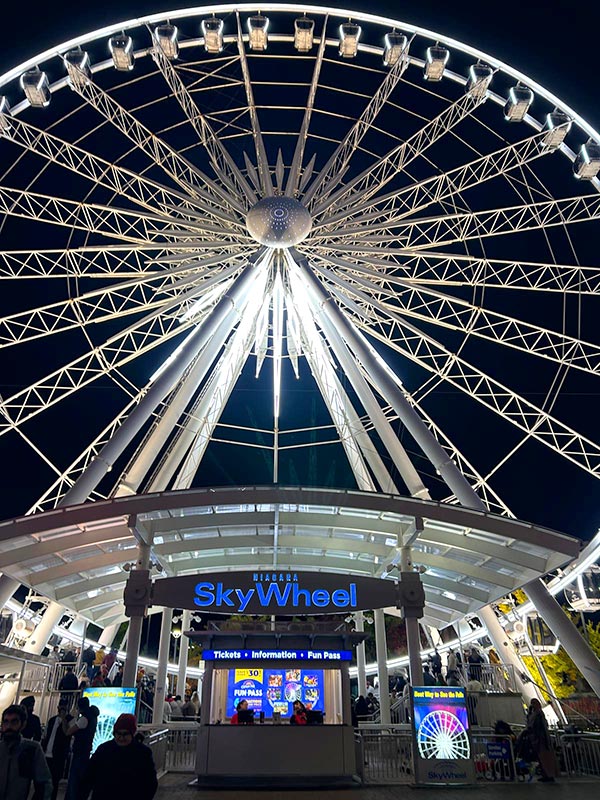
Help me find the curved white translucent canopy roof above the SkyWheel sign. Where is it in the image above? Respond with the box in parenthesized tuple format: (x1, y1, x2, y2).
(0, 486, 580, 628)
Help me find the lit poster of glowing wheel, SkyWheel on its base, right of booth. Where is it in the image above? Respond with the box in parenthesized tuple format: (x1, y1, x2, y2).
(411, 686, 474, 784)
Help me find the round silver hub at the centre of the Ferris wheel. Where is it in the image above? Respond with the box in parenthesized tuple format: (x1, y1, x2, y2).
(246, 197, 312, 248)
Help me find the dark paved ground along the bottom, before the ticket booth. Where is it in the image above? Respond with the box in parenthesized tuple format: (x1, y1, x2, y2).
(155, 774, 600, 800)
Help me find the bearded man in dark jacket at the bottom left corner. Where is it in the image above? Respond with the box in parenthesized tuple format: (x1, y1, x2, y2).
(0, 705, 52, 800)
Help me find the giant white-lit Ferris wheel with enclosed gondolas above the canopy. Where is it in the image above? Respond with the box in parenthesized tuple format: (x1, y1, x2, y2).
(0, 4, 600, 514)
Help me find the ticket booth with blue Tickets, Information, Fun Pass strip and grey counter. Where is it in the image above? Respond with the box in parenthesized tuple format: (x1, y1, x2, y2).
(189, 628, 364, 786)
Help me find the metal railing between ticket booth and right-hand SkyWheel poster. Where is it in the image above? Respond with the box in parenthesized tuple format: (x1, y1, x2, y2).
(354, 725, 413, 784)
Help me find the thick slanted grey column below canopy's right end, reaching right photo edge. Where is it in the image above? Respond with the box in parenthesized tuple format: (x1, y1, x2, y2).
(523, 580, 600, 697)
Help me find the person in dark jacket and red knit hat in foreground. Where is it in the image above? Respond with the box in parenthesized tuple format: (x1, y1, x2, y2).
(80, 714, 158, 800)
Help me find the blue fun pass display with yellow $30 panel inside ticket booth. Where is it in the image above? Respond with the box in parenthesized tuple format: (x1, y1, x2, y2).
(227, 667, 325, 719)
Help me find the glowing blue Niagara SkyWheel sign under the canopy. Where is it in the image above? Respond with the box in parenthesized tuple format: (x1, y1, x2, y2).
(151, 571, 399, 615)
